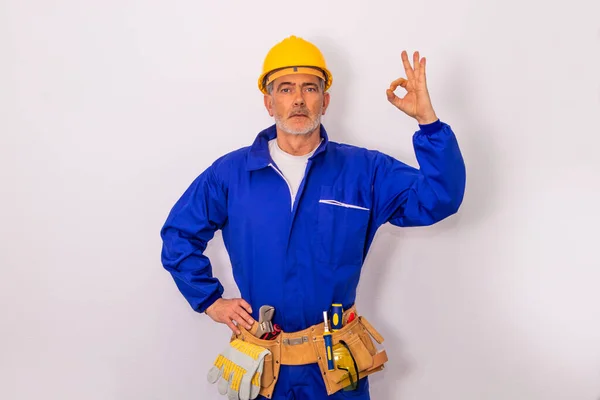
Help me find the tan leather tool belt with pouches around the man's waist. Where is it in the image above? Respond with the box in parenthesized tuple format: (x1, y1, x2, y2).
(231, 306, 388, 398)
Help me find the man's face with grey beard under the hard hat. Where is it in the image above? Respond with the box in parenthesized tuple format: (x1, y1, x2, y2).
(265, 74, 329, 135)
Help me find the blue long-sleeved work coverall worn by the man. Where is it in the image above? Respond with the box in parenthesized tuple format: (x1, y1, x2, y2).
(161, 120, 466, 400)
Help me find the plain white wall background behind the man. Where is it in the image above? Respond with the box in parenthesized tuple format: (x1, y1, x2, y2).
(0, 0, 600, 400)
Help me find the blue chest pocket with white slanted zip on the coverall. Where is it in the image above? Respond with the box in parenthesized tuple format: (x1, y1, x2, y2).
(316, 186, 371, 265)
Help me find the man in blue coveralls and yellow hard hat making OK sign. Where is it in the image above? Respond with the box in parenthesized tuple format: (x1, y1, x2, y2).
(161, 36, 465, 400)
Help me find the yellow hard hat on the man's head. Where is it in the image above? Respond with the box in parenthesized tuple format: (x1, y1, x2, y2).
(258, 35, 333, 94)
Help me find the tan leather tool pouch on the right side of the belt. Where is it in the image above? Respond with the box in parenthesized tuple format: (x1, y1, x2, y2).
(314, 317, 388, 395)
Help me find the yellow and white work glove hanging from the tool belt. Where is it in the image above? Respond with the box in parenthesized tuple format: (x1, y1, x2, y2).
(208, 339, 270, 400)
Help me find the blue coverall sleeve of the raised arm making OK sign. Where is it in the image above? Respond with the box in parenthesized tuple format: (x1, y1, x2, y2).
(373, 120, 466, 227)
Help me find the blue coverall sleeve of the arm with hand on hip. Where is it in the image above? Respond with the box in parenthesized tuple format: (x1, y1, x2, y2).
(160, 164, 227, 312)
